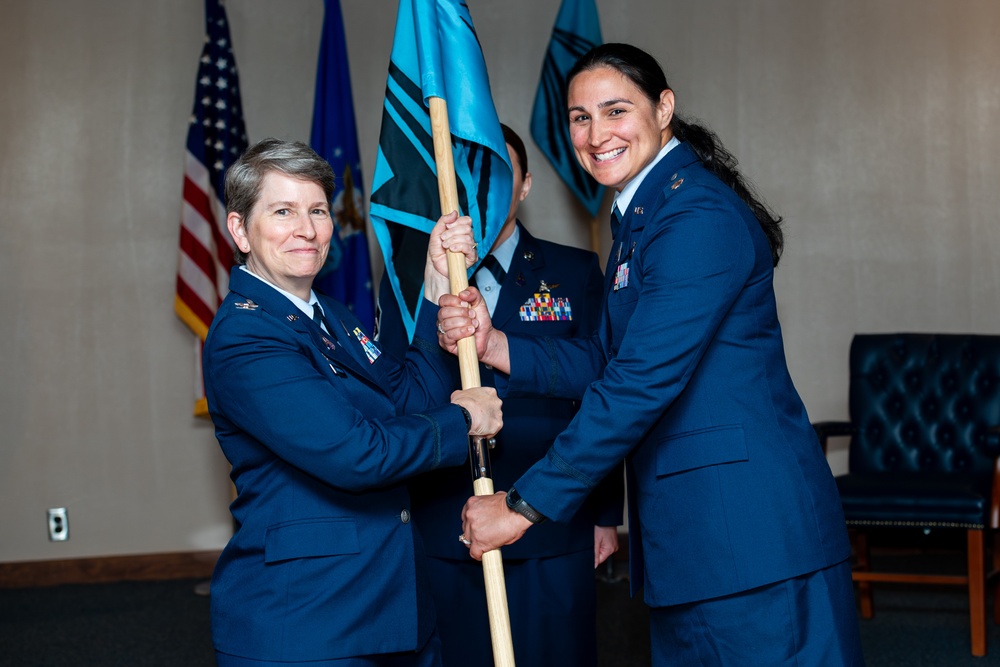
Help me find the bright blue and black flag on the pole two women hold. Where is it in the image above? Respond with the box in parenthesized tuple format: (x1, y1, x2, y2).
(371, 0, 513, 338)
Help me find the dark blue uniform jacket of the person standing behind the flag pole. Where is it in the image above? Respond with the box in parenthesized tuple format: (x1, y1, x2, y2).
(379, 222, 625, 560)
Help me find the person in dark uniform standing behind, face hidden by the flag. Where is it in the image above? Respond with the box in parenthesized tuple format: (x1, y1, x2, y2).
(378, 125, 624, 667)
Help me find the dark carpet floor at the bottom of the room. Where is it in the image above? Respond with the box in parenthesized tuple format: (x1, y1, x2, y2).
(0, 560, 1000, 667)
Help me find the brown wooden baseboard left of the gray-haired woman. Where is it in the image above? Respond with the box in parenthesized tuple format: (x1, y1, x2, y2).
(0, 551, 219, 588)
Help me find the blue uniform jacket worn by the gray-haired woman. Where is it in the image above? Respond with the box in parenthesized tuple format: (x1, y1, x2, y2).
(204, 269, 468, 662)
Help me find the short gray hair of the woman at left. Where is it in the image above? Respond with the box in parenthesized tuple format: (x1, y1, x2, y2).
(226, 138, 334, 264)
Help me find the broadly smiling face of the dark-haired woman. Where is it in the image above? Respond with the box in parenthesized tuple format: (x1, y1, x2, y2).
(568, 67, 674, 190)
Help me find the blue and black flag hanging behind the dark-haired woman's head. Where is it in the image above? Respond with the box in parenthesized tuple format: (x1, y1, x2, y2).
(531, 0, 604, 216)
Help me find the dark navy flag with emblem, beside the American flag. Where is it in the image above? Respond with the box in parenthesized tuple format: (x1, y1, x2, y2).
(310, 0, 375, 331)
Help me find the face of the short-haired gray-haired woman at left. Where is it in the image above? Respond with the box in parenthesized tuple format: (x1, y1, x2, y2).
(227, 171, 333, 301)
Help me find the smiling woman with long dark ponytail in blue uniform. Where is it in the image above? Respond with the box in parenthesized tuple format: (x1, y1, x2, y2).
(439, 44, 863, 667)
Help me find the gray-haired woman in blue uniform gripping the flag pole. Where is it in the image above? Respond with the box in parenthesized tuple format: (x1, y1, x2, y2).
(204, 139, 501, 667)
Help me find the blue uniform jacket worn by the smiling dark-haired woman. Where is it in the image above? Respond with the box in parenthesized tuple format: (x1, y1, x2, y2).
(498, 144, 849, 607)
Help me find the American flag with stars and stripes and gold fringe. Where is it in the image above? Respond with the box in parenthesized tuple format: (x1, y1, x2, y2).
(174, 0, 247, 415)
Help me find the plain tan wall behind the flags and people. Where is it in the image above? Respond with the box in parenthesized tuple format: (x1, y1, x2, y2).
(0, 0, 1000, 562)
